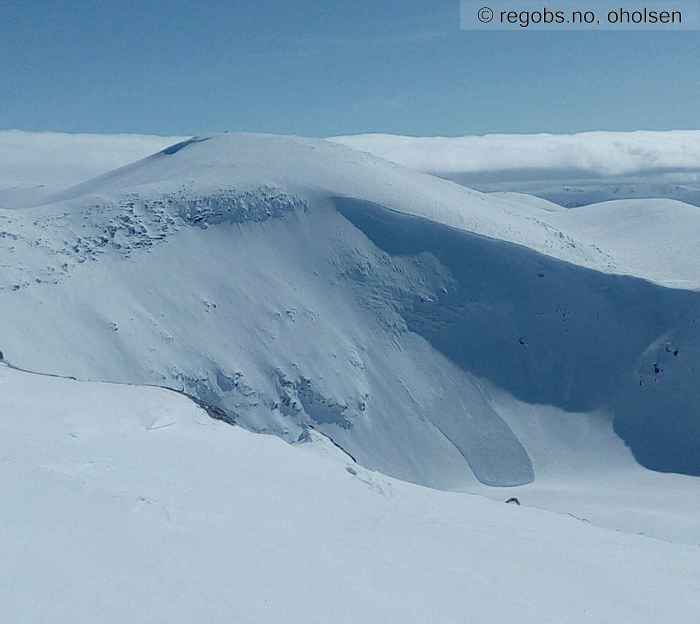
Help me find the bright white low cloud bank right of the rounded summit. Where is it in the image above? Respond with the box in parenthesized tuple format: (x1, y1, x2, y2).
(331, 130, 700, 178)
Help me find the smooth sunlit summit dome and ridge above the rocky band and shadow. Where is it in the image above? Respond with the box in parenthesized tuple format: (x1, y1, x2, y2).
(31, 134, 684, 281)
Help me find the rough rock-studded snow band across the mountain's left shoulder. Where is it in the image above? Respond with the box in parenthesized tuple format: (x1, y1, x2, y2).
(0, 186, 306, 291)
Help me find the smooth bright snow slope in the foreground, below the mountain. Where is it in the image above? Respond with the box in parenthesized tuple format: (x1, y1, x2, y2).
(5, 365, 700, 624)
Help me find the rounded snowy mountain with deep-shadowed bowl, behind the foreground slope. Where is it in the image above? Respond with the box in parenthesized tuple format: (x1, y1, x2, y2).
(0, 135, 700, 488)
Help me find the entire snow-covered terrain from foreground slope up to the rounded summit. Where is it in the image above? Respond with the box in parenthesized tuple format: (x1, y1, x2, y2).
(0, 130, 700, 624)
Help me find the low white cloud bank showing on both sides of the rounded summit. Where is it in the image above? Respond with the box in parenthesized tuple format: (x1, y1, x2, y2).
(5, 130, 700, 189)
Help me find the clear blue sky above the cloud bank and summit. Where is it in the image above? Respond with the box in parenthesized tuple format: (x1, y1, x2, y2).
(0, 0, 700, 136)
